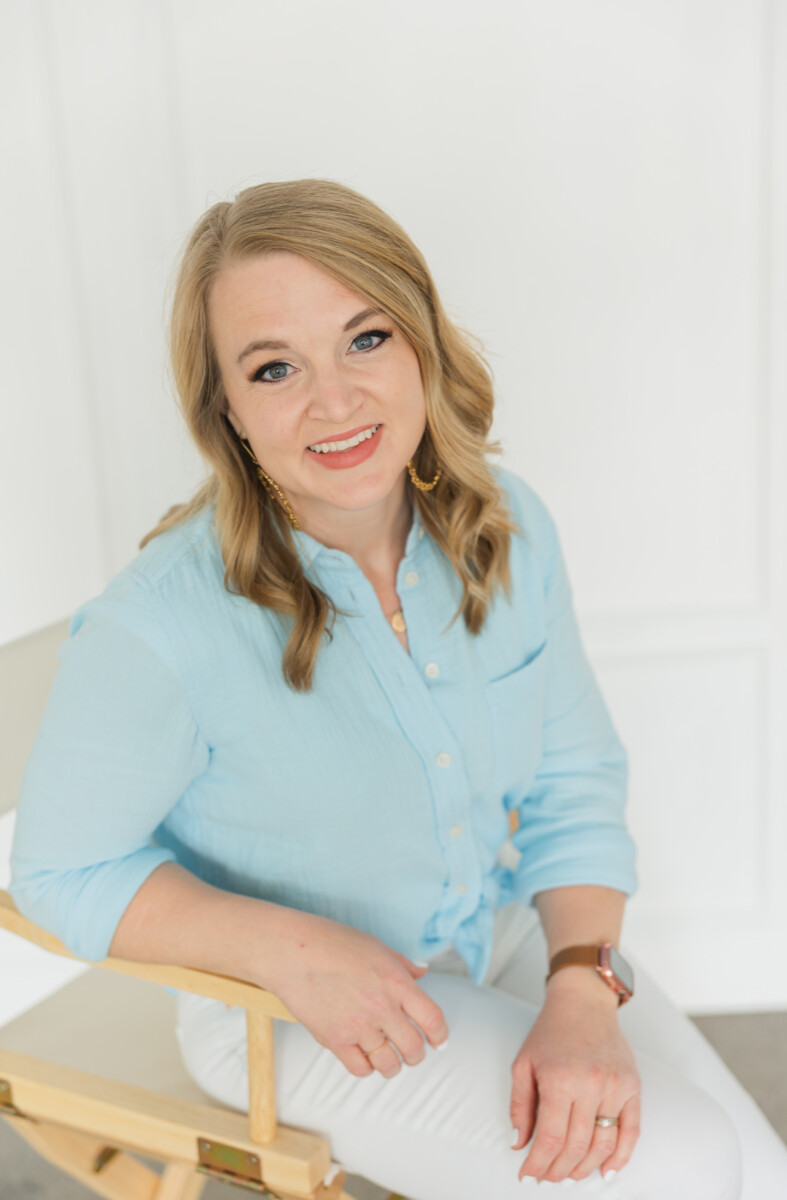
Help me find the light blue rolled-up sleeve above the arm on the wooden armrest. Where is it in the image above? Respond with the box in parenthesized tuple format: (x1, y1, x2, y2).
(10, 581, 210, 962)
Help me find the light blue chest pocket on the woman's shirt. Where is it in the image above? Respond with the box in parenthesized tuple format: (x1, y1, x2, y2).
(483, 641, 547, 803)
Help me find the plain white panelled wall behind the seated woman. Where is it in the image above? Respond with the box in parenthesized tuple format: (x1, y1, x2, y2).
(0, 0, 787, 1012)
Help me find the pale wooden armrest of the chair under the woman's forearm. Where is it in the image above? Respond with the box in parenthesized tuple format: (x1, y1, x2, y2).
(0, 888, 298, 1021)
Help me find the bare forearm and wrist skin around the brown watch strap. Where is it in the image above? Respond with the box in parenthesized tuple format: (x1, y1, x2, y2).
(534, 884, 626, 1006)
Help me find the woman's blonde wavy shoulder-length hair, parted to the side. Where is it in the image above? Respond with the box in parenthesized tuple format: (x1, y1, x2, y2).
(139, 179, 519, 691)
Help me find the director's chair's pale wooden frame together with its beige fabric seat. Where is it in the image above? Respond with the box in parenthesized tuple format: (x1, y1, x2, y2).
(0, 890, 404, 1200)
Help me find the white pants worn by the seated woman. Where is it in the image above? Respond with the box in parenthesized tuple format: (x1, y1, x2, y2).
(176, 902, 787, 1200)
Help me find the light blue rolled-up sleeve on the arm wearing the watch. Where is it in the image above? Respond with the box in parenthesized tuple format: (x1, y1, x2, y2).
(511, 486, 637, 905)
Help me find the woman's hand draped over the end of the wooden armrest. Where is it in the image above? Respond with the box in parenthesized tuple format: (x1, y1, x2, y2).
(263, 911, 449, 1079)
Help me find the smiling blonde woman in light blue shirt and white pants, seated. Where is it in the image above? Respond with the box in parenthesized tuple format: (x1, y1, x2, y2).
(11, 180, 787, 1200)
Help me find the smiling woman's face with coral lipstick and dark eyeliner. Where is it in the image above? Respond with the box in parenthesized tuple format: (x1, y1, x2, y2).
(208, 252, 426, 530)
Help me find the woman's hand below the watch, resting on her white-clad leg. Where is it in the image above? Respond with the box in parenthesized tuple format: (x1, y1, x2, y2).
(511, 967, 641, 1182)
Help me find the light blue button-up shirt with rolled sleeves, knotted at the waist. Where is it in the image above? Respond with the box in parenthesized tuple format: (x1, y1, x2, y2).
(10, 466, 636, 983)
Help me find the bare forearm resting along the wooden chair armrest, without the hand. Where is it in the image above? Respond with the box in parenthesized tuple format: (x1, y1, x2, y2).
(109, 863, 310, 991)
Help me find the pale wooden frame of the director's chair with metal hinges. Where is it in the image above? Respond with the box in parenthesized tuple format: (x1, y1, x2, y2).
(0, 890, 403, 1200)
